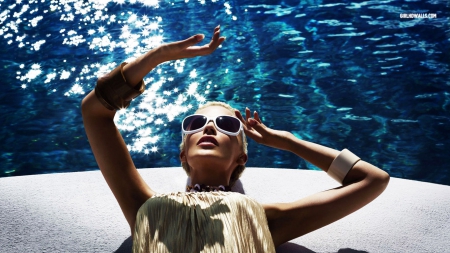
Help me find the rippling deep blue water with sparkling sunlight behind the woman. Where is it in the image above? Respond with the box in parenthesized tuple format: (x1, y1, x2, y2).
(0, 0, 450, 185)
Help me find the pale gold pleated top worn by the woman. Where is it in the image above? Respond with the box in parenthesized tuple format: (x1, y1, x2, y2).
(133, 192, 275, 253)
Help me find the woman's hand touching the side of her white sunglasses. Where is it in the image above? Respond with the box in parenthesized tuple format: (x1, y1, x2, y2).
(235, 108, 287, 149)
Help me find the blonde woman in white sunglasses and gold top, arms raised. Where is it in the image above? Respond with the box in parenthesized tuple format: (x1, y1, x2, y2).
(82, 27, 389, 252)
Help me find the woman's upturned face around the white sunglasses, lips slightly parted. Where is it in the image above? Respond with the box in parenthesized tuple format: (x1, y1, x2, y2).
(180, 106, 247, 176)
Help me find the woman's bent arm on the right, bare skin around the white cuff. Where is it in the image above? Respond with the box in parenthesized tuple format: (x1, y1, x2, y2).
(236, 109, 389, 246)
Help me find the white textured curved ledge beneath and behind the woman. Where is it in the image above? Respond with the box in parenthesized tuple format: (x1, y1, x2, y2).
(0, 168, 450, 253)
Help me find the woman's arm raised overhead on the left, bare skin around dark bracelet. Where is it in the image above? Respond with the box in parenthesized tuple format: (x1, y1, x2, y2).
(81, 27, 225, 232)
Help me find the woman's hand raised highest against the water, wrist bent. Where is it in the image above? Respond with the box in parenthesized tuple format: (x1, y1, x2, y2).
(159, 25, 225, 61)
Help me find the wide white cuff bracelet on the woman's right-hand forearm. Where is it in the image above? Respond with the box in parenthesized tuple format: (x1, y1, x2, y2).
(327, 149, 361, 184)
